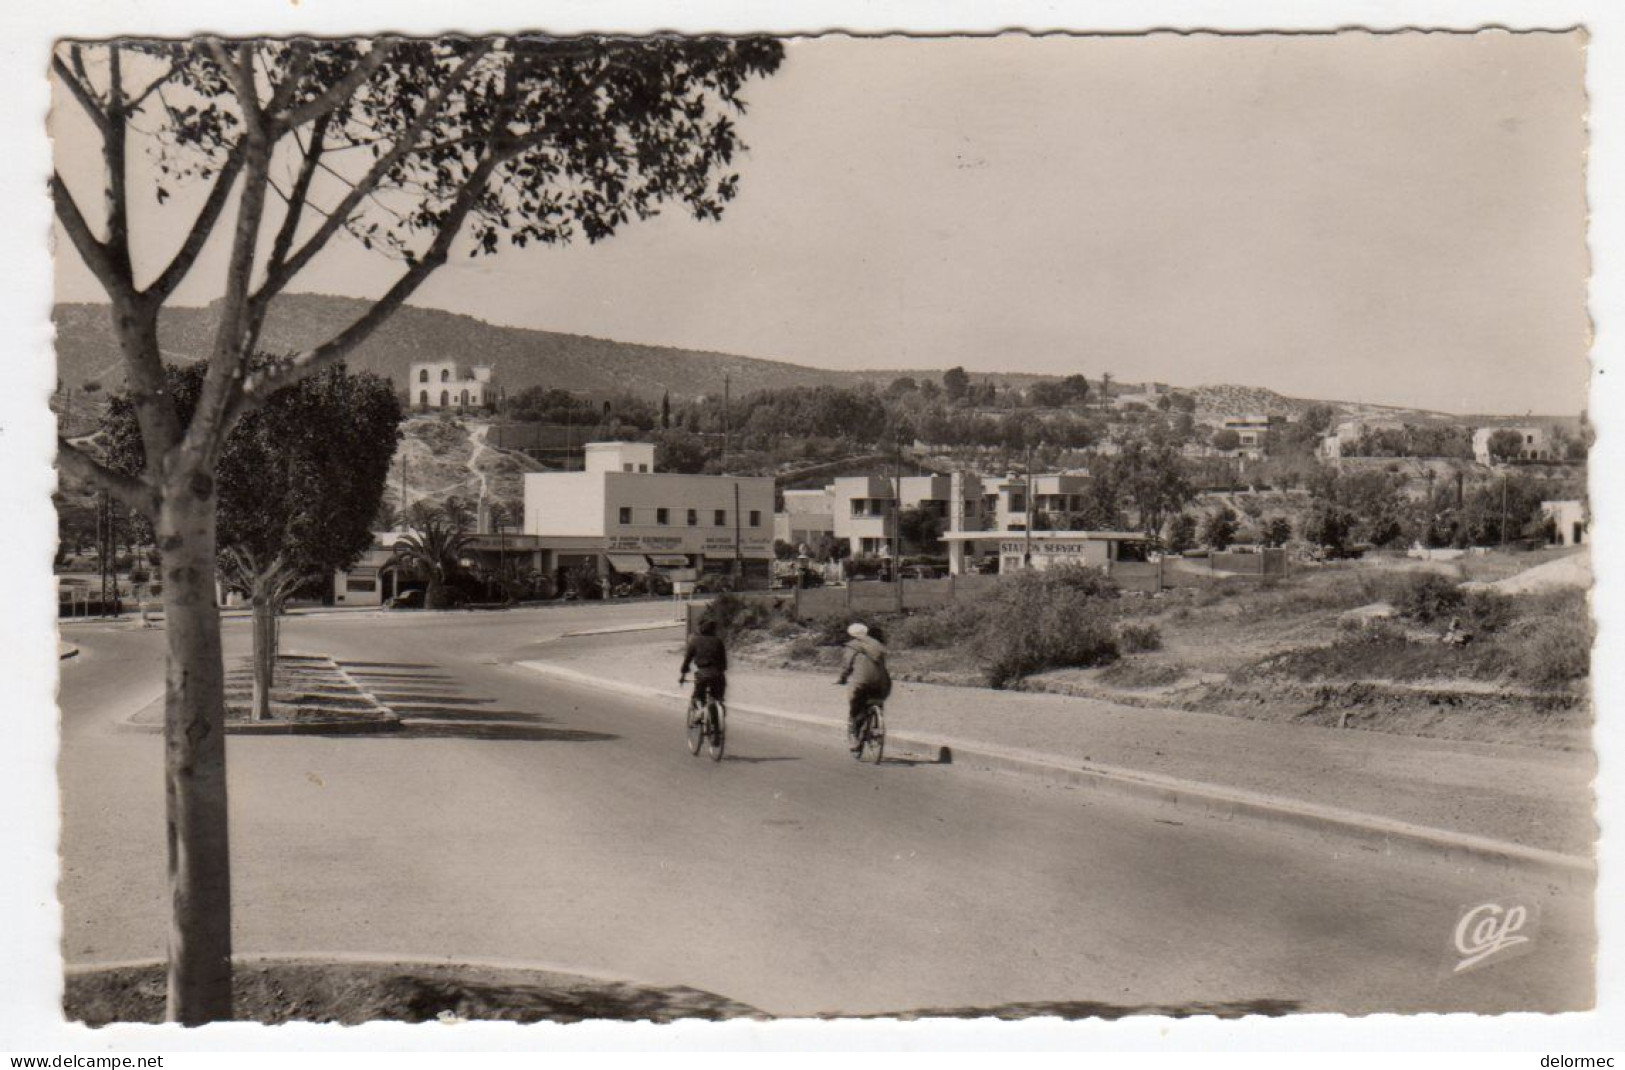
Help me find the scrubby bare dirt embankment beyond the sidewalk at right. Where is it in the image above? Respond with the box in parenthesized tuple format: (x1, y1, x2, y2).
(738, 555, 1593, 750)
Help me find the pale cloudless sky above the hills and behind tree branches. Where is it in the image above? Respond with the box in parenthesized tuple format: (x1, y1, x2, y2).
(54, 31, 1589, 415)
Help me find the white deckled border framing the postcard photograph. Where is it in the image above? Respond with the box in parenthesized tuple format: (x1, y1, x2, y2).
(0, 0, 1625, 1047)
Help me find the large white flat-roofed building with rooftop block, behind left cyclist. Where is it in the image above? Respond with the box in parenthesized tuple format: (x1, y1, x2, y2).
(525, 442, 774, 579)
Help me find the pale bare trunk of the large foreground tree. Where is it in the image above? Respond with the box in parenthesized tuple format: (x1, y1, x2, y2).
(158, 475, 232, 1026)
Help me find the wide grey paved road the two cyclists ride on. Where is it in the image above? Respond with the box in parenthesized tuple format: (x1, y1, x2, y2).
(62, 607, 1593, 1015)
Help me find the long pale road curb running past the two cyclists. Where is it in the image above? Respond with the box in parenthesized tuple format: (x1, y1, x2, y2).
(515, 660, 1596, 881)
